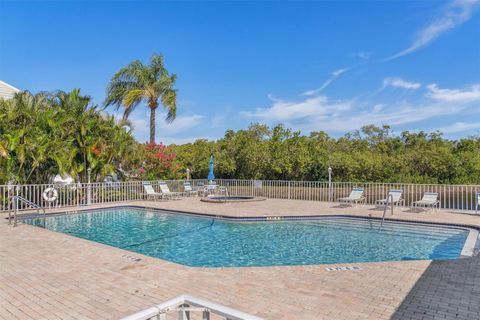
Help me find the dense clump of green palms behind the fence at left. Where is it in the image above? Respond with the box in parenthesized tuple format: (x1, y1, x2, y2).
(0, 89, 139, 183)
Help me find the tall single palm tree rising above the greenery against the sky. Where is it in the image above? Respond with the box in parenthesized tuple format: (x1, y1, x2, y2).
(105, 54, 177, 143)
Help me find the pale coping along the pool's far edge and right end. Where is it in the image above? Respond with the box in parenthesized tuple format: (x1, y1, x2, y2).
(17, 204, 480, 259)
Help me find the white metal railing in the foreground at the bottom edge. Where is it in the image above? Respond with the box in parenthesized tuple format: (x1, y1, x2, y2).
(121, 294, 263, 320)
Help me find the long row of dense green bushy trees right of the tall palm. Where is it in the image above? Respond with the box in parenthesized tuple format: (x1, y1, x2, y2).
(170, 124, 480, 184)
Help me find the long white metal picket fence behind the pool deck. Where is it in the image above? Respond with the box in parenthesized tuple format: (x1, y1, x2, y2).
(0, 179, 480, 212)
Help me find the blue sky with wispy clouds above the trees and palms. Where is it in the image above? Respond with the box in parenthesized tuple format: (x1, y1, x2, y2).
(0, 0, 480, 143)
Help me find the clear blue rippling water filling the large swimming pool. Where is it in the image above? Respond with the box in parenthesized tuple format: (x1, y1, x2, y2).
(26, 208, 468, 267)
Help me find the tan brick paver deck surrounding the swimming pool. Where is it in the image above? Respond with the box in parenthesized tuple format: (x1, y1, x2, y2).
(0, 198, 480, 320)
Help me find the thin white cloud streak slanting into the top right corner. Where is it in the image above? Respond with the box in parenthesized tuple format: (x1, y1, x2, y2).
(386, 0, 480, 60)
